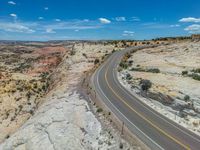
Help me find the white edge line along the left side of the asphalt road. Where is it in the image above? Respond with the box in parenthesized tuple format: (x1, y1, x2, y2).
(94, 58, 164, 150)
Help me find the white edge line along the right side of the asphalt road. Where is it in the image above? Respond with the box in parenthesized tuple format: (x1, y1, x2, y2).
(113, 52, 200, 142)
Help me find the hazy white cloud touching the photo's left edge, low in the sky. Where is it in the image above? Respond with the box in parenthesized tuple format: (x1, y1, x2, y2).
(0, 22, 35, 33)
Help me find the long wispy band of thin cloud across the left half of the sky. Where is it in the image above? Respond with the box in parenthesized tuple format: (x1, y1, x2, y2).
(0, 18, 103, 35)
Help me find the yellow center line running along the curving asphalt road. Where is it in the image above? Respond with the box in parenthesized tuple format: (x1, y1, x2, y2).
(105, 59, 190, 150)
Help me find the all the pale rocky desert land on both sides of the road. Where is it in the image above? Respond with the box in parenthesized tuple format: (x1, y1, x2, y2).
(0, 38, 200, 150)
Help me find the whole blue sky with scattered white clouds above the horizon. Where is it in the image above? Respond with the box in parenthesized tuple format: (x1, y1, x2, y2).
(0, 0, 200, 41)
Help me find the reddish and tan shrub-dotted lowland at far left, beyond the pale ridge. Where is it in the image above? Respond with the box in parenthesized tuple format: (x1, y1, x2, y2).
(0, 43, 68, 143)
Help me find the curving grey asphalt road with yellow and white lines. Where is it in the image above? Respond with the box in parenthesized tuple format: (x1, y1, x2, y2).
(91, 46, 200, 150)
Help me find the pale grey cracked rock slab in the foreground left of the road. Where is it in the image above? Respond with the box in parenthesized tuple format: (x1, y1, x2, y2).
(0, 93, 113, 150)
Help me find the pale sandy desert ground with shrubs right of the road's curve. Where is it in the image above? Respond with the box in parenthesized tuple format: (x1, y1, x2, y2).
(118, 39, 200, 135)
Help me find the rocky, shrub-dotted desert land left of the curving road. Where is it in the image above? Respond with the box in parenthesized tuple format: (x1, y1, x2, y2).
(0, 41, 146, 150)
